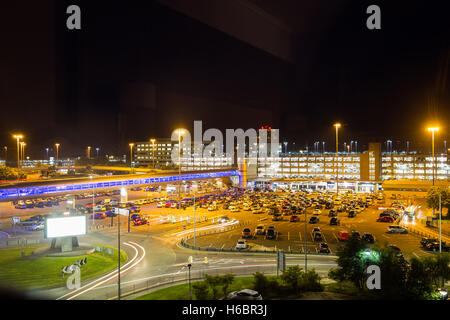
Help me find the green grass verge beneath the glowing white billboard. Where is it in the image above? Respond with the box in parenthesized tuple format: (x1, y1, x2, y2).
(0, 244, 128, 290)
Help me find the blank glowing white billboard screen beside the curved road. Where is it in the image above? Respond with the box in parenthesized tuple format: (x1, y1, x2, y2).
(44, 215, 87, 238)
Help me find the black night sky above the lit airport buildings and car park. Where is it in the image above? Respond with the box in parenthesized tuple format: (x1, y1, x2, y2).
(0, 0, 450, 158)
